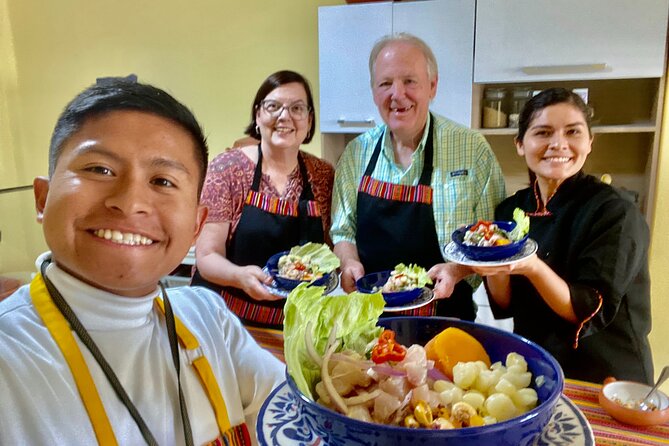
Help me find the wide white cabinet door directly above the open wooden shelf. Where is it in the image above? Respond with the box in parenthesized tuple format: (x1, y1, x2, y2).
(474, 0, 669, 83)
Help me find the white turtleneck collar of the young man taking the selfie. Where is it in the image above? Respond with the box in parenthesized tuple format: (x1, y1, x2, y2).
(40, 263, 160, 330)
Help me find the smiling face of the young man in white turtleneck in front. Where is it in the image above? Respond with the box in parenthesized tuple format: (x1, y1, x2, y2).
(34, 111, 207, 296)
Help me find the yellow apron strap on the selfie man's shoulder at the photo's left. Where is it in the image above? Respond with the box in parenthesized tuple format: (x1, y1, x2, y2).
(30, 274, 118, 445)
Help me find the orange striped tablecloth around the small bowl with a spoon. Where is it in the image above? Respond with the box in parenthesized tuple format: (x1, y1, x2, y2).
(564, 379, 669, 446)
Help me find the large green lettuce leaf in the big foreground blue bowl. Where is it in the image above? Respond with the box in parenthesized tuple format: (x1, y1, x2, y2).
(283, 284, 385, 399)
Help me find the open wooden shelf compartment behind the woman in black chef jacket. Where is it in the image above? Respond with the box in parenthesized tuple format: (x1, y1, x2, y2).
(472, 77, 665, 222)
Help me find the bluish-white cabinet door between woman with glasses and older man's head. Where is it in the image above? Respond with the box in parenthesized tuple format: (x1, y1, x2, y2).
(318, 3, 392, 133)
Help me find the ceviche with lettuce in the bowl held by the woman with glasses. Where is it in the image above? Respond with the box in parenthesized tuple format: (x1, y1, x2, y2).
(278, 242, 339, 281)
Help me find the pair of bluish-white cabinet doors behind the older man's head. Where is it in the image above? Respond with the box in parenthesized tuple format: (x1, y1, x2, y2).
(318, 0, 475, 133)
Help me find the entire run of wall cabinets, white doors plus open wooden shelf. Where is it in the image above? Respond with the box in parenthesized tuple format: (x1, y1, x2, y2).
(319, 0, 669, 221)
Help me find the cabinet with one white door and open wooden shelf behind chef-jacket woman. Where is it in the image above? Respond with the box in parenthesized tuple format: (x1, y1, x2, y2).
(472, 0, 669, 221)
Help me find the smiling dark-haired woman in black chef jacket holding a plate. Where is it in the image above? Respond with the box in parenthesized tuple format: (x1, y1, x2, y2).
(474, 88, 653, 382)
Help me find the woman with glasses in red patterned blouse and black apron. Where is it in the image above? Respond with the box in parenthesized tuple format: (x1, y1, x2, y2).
(191, 71, 334, 328)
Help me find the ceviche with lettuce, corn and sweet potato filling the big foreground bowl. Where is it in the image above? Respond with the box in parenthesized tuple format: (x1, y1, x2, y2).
(284, 285, 543, 429)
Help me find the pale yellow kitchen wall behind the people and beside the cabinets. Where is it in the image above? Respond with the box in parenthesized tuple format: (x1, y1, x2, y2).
(0, 0, 669, 388)
